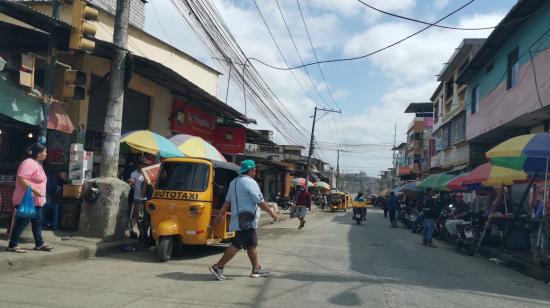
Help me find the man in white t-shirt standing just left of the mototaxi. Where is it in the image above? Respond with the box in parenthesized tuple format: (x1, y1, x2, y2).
(128, 157, 147, 238)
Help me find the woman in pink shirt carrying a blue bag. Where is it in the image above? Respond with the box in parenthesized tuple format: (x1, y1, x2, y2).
(7, 143, 52, 253)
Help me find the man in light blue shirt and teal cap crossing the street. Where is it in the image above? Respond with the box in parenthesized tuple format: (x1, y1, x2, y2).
(208, 160, 277, 280)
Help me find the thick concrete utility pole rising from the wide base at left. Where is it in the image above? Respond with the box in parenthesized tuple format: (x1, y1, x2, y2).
(100, 0, 130, 178)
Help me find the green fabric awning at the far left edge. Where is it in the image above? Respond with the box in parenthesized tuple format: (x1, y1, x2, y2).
(0, 73, 44, 125)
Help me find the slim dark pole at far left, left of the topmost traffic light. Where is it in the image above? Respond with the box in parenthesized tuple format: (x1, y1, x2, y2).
(39, 0, 61, 145)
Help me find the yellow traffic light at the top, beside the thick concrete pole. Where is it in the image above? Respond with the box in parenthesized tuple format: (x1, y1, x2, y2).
(69, 0, 99, 51)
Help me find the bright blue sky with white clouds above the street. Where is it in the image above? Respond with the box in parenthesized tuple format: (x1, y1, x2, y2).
(141, 0, 516, 176)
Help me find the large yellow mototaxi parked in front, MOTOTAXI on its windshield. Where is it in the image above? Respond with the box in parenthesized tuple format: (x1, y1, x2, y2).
(146, 157, 239, 262)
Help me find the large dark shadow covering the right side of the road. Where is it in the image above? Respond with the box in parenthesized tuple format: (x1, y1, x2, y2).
(330, 210, 550, 304)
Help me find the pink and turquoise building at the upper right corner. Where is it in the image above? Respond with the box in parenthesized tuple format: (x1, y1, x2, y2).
(458, 0, 550, 165)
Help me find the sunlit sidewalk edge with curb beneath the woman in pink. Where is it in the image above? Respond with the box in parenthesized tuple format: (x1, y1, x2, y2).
(0, 240, 137, 275)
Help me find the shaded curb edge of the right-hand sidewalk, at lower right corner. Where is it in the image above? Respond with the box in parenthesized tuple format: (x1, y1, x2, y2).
(478, 246, 550, 283)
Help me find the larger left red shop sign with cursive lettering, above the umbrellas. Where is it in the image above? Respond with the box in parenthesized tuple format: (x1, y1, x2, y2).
(170, 98, 217, 142)
